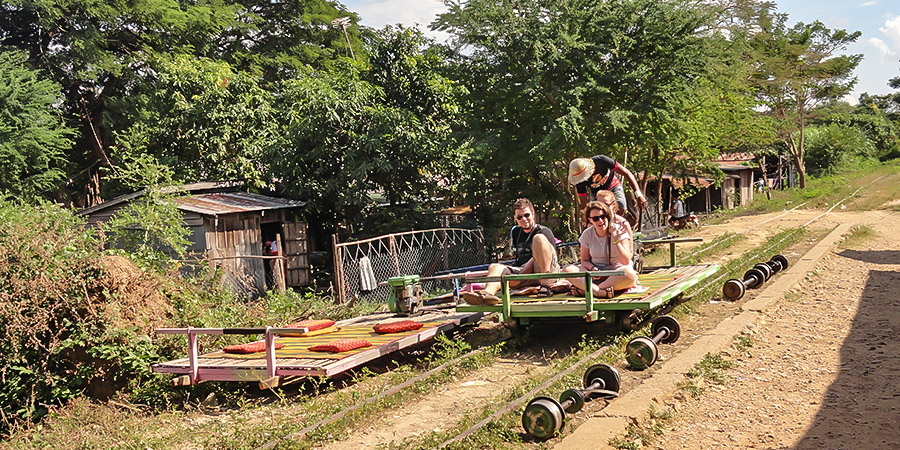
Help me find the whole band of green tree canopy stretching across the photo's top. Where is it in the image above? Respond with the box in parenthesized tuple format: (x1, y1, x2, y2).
(0, 0, 888, 241)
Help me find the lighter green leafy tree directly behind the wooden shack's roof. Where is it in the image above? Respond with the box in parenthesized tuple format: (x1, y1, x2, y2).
(110, 55, 277, 188)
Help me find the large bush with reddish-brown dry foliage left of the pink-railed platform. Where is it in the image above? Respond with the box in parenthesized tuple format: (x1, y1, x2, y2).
(0, 200, 173, 435)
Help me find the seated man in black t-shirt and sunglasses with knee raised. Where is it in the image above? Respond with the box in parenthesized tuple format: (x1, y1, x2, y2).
(463, 198, 559, 305)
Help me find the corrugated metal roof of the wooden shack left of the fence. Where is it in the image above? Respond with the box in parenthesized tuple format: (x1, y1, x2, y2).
(172, 192, 306, 216)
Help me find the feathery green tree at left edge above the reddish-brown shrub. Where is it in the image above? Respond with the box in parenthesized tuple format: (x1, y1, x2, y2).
(0, 50, 73, 201)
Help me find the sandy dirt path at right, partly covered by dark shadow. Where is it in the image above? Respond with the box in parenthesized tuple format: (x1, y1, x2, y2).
(652, 211, 900, 449)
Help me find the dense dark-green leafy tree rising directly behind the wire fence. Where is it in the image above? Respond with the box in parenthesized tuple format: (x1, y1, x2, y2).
(272, 27, 462, 236)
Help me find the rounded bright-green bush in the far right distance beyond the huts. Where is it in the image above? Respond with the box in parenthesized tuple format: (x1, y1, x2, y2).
(806, 124, 877, 176)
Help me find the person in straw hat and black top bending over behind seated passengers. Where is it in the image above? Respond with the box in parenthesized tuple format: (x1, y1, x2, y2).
(569, 155, 647, 212)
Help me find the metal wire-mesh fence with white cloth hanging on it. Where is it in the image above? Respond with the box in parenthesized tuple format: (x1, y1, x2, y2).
(332, 228, 487, 303)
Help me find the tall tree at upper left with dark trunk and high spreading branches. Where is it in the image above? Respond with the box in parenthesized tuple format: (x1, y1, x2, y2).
(0, 0, 359, 206)
